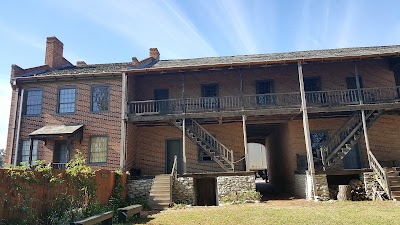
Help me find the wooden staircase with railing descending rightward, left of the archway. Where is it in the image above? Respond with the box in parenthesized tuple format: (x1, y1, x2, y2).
(172, 119, 235, 172)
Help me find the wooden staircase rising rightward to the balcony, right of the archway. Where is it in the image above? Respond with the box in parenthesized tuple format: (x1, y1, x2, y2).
(320, 110, 382, 169)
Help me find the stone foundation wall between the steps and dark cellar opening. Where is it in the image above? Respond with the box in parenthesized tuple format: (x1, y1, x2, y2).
(172, 177, 194, 205)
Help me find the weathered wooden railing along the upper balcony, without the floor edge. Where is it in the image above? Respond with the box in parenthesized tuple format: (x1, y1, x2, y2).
(129, 86, 400, 115)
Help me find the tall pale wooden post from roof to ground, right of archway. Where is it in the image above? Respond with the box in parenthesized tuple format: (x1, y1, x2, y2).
(297, 61, 317, 199)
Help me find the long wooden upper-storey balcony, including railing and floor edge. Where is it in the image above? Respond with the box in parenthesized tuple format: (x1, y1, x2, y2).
(129, 86, 400, 121)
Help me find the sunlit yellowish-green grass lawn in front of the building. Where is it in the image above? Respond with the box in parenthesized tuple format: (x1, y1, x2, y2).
(129, 200, 400, 225)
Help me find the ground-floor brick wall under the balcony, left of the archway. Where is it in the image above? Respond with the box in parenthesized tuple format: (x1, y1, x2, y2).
(128, 123, 244, 175)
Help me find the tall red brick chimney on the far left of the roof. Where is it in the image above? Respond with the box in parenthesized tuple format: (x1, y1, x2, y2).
(45, 36, 65, 68)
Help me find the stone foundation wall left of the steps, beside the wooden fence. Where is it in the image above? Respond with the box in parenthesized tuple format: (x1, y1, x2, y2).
(127, 178, 153, 199)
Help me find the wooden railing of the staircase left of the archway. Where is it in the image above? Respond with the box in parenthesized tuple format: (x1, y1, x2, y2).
(188, 120, 235, 170)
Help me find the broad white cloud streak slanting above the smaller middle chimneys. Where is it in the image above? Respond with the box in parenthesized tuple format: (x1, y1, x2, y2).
(49, 0, 218, 58)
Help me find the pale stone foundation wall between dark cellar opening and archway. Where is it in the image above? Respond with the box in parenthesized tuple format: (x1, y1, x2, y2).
(217, 175, 256, 201)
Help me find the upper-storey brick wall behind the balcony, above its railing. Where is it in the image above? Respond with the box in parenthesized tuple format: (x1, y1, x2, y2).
(130, 59, 395, 100)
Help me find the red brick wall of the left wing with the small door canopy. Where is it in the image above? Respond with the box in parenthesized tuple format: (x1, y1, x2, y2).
(7, 78, 121, 169)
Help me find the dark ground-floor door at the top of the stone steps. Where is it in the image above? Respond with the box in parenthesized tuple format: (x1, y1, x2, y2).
(165, 140, 183, 174)
